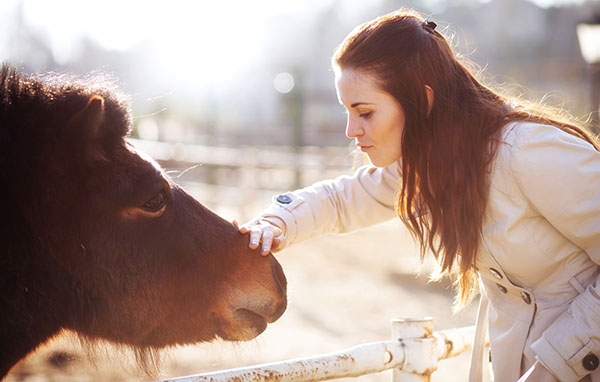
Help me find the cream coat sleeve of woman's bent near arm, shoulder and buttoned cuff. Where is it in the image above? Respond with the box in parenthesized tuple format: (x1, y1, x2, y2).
(511, 125, 600, 381)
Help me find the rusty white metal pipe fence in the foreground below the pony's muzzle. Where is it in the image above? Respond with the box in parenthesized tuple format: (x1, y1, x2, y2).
(159, 318, 482, 382)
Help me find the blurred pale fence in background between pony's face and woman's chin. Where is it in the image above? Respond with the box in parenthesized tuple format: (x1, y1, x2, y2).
(129, 139, 354, 218)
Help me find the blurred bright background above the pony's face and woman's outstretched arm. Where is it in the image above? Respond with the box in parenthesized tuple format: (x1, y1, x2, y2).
(0, 0, 600, 220)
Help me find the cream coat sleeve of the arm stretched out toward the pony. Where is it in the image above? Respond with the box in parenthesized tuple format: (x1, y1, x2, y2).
(252, 162, 401, 250)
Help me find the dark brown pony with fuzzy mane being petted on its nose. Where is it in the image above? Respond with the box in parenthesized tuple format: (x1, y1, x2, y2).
(0, 65, 286, 378)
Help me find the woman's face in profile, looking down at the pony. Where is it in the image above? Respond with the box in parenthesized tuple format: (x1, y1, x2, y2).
(336, 69, 405, 167)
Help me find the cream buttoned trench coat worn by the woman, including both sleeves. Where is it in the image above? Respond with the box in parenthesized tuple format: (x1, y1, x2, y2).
(262, 123, 600, 382)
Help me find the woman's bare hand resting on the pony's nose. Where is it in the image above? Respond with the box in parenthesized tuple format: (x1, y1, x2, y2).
(232, 218, 285, 256)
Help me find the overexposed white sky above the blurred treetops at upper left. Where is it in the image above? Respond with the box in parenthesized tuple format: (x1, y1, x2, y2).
(0, 0, 342, 85)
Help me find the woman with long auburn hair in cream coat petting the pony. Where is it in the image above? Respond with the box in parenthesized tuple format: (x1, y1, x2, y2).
(240, 11, 600, 381)
